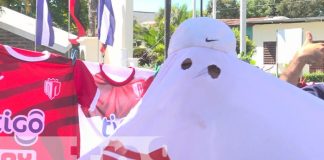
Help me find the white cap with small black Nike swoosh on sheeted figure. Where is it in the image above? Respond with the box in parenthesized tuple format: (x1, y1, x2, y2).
(168, 17, 236, 57)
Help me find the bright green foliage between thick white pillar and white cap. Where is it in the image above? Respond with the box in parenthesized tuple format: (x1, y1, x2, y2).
(134, 5, 190, 68)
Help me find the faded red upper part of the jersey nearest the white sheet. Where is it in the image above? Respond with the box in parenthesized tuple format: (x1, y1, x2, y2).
(78, 64, 153, 119)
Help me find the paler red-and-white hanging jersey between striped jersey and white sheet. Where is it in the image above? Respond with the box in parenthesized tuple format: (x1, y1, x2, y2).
(76, 61, 154, 159)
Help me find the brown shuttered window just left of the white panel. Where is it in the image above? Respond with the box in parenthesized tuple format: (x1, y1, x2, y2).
(263, 42, 277, 64)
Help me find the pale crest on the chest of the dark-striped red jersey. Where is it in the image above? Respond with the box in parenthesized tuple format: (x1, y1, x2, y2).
(44, 78, 61, 100)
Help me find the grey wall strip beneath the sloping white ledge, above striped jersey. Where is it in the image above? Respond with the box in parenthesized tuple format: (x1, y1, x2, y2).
(0, 28, 63, 54)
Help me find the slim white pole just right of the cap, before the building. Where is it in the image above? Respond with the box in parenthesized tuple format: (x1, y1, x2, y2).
(240, 0, 246, 53)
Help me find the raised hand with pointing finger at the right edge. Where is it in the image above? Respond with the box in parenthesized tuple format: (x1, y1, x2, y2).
(297, 32, 324, 64)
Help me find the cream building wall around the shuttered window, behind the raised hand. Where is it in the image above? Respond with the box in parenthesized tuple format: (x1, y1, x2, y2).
(253, 22, 324, 73)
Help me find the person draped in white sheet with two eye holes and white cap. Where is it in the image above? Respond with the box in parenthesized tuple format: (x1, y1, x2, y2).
(104, 18, 324, 160)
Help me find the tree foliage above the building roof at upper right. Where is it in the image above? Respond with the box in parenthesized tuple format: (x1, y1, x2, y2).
(207, 0, 324, 19)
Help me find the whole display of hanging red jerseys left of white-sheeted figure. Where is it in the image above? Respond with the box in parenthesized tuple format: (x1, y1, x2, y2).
(0, 45, 154, 160)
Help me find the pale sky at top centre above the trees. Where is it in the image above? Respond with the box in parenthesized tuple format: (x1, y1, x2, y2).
(133, 0, 209, 12)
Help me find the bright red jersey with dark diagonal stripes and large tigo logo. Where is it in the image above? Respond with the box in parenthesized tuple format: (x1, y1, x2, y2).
(0, 45, 95, 160)
